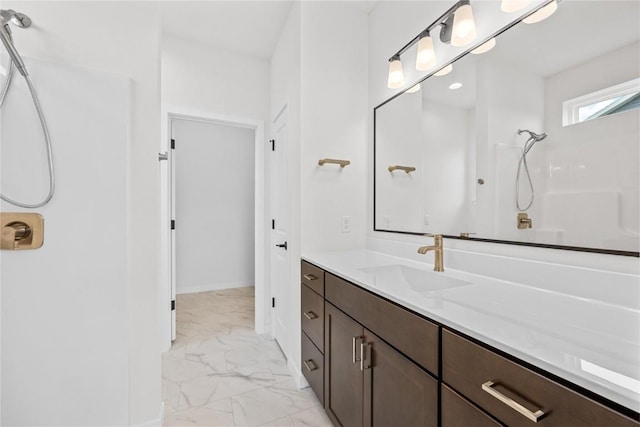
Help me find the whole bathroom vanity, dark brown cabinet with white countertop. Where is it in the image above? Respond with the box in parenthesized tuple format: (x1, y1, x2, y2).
(301, 256, 640, 427)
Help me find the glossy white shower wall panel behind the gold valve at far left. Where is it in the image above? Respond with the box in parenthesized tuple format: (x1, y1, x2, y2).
(0, 60, 131, 425)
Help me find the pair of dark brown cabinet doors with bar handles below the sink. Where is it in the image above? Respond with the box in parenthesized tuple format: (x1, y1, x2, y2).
(324, 303, 438, 427)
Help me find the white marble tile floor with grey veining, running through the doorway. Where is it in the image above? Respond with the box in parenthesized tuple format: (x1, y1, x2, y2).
(162, 287, 331, 427)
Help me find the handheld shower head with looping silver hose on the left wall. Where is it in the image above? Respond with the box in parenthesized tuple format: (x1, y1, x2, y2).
(0, 9, 55, 208)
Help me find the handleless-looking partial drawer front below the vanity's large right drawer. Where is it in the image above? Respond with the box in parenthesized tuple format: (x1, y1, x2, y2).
(441, 384, 502, 427)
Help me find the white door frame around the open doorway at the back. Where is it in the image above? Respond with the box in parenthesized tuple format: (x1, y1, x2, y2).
(158, 105, 271, 351)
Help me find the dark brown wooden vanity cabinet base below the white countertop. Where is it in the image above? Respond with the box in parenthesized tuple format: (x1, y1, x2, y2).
(302, 262, 640, 427)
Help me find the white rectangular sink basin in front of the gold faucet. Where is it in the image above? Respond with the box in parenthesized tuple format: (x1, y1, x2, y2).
(360, 264, 471, 292)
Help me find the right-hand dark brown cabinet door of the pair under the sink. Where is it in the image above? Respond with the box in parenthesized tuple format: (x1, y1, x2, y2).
(363, 330, 438, 427)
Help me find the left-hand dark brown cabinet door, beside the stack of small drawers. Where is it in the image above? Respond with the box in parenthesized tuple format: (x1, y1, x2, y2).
(324, 303, 364, 427)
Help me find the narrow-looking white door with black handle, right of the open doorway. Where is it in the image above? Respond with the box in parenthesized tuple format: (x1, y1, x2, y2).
(271, 107, 290, 354)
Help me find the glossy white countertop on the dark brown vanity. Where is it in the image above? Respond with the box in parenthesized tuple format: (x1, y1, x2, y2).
(303, 250, 640, 412)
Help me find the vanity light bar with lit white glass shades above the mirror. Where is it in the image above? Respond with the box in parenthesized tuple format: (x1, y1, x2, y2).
(387, 0, 476, 89)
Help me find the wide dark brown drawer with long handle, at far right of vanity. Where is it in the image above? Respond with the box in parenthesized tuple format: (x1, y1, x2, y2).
(442, 329, 638, 427)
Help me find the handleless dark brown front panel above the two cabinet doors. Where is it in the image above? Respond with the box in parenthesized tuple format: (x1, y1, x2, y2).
(325, 273, 440, 376)
